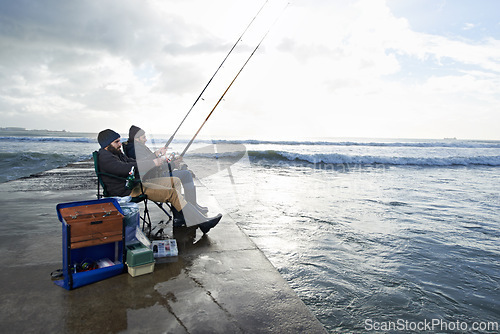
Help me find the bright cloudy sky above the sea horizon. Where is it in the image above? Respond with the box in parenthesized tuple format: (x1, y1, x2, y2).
(0, 0, 500, 140)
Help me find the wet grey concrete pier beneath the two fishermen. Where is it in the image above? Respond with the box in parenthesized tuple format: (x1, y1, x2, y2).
(0, 162, 326, 333)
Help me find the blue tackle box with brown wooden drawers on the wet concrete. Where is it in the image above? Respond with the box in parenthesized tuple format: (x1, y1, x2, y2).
(55, 198, 125, 290)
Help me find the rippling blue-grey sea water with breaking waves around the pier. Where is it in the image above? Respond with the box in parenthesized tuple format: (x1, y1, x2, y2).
(0, 136, 500, 333)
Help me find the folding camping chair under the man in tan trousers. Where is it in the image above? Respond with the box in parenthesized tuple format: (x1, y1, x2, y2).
(92, 151, 172, 237)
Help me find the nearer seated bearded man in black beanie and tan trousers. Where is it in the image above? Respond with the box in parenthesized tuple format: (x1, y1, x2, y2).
(97, 129, 222, 233)
